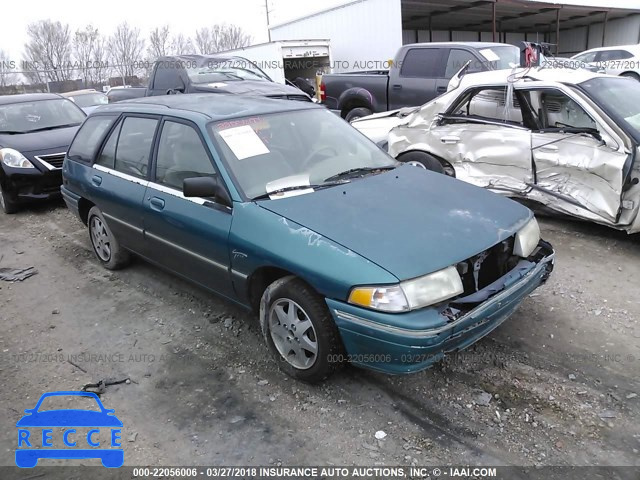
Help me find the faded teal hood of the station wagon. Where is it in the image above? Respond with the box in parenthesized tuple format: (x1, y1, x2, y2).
(259, 165, 533, 280)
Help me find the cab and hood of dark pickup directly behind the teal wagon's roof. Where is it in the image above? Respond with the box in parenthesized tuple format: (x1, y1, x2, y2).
(146, 55, 311, 102)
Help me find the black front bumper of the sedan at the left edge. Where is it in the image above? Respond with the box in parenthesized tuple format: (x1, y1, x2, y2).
(2, 167, 62, 203)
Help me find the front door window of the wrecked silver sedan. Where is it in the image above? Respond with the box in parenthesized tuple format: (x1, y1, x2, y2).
(529, 88, 597, 129)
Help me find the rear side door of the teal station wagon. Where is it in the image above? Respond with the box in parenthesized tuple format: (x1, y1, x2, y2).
(89, 115, 159, 253)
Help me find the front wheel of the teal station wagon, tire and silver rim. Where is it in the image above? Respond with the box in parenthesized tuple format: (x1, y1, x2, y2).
(260, 276, 344, 383)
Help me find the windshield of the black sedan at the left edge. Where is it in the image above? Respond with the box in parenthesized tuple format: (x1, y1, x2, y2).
(0, 98, 86, 133)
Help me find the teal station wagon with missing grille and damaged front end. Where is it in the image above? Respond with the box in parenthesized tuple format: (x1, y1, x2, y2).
(62, 94, 554, 382)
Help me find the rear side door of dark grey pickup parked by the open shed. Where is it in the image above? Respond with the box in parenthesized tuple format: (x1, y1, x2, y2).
(387, 47, 448, 110)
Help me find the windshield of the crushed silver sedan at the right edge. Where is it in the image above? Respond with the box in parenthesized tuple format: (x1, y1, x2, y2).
(580, 77, 640, 139)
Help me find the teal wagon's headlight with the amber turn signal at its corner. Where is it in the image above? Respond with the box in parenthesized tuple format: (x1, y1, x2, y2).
(349, 267, 464, 312)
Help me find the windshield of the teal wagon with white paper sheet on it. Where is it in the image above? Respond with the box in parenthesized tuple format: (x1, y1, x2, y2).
(209, 109, 396, 198)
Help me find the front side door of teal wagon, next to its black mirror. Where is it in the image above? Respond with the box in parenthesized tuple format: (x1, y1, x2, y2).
(144, 118, 233, 296)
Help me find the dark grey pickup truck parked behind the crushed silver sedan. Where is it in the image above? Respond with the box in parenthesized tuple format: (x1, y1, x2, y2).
(320, 42, 520, 122)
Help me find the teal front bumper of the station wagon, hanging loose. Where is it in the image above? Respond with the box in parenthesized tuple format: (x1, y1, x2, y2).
(326, 241, 554, 374)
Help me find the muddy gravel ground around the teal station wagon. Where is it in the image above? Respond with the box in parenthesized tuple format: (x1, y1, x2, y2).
(0, 204, 640, 474)
